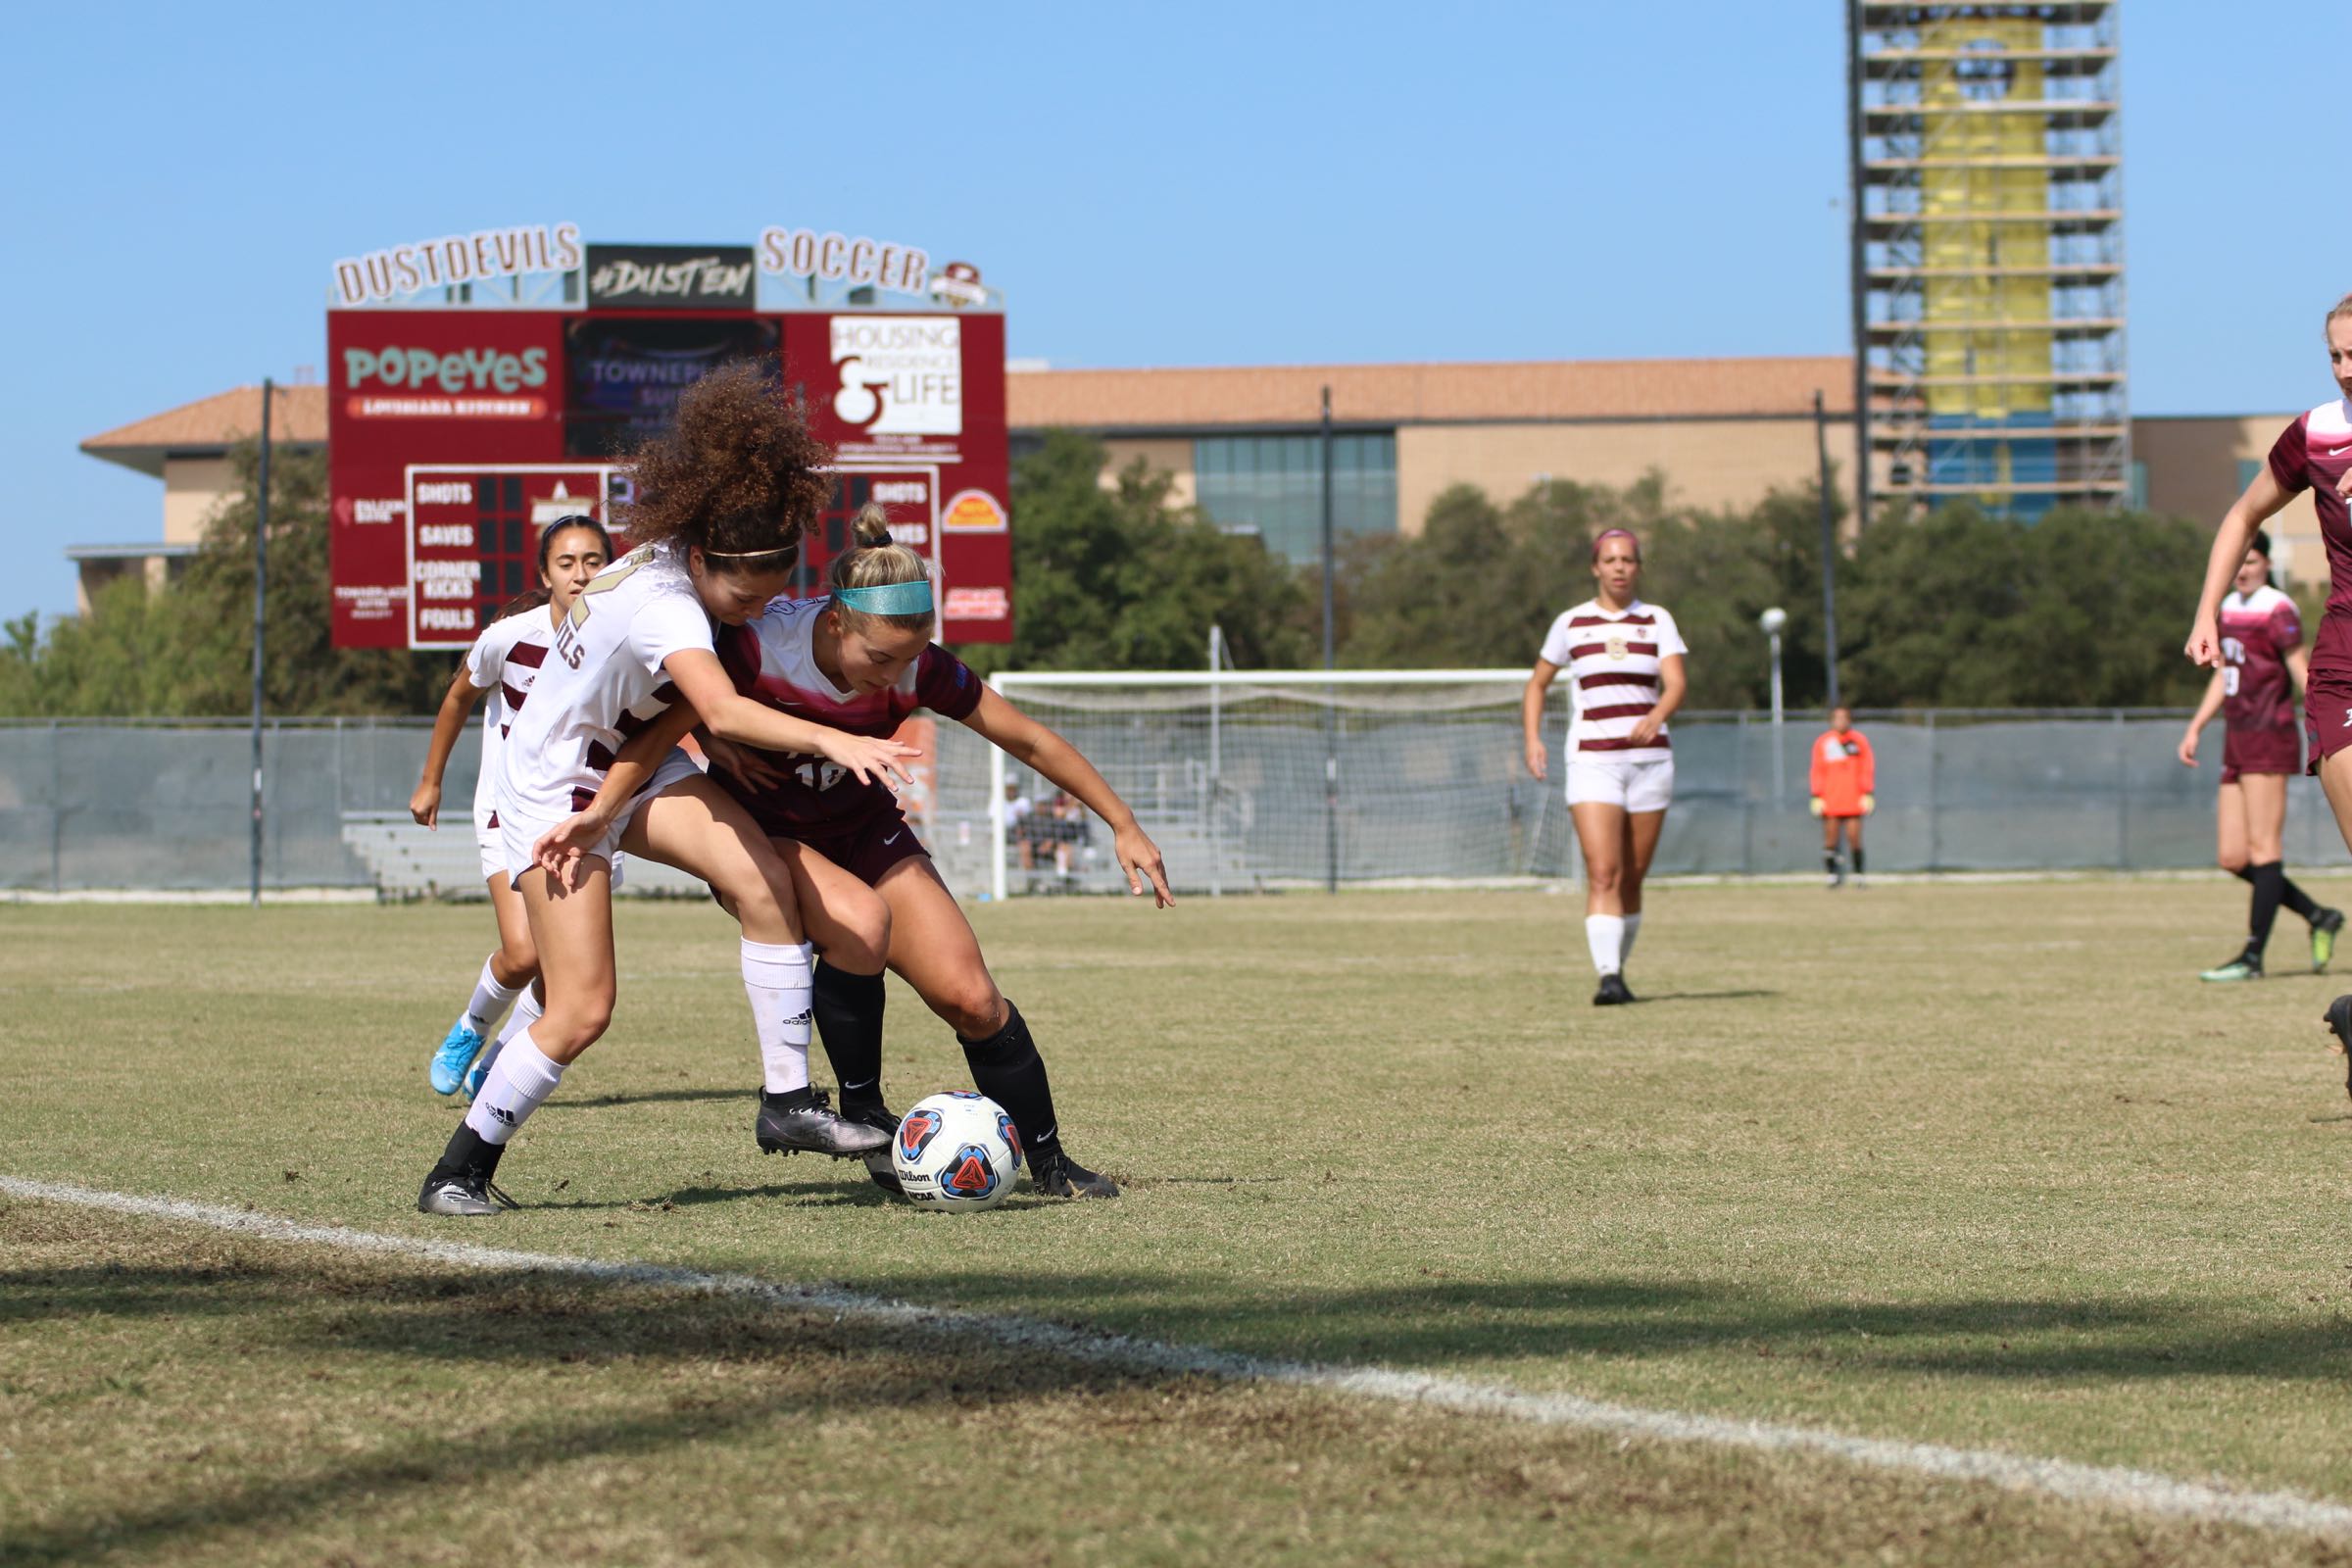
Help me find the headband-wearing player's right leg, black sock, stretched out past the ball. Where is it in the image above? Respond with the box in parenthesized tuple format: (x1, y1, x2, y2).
(880, 856, 1119, 1199)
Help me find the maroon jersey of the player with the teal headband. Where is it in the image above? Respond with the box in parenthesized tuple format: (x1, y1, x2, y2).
(710, 597, 981, 832)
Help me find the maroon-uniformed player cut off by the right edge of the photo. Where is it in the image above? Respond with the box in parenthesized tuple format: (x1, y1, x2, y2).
(2185, 294, 2352, 1093)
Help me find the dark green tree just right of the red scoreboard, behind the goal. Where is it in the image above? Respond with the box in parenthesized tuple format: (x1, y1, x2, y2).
(959, 430, 1312, 672)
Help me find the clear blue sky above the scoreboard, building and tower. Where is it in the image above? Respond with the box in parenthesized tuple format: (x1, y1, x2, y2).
(0, 0, 2352, 613)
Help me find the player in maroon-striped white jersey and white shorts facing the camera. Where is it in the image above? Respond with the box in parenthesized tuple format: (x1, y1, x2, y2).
(1519, 529, 1689, 1006)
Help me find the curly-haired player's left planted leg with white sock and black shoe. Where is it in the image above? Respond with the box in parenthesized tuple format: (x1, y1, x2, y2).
(416, 856, 613, 1215)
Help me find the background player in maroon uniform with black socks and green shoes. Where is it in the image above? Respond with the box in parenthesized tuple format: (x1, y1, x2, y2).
(2180, 531, 2345, 980)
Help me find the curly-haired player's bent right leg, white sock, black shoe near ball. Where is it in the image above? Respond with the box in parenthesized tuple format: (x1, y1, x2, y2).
(620, 773, 889, 1159)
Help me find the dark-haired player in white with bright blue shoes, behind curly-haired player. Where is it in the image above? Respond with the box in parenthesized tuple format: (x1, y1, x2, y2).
(410, 517, 612, 1096)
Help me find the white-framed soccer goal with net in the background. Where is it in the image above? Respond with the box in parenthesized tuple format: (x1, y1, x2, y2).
(988, 670, 1574, 898)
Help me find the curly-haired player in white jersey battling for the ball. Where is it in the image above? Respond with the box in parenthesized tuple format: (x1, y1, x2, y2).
(416, 365, 910, 1215)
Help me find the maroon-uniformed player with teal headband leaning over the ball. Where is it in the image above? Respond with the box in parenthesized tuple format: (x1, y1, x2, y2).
(595, 506, 1176, 1197)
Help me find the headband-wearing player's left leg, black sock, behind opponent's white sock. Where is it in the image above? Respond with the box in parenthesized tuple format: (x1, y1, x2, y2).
(769, 837, 899, 1192)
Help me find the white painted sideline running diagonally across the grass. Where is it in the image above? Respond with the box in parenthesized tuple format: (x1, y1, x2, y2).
(14, 1175, 2352, 1538)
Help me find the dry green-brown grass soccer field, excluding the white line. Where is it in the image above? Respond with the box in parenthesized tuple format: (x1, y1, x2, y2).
(0, 877, 2352, 1568)
